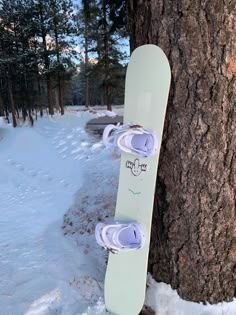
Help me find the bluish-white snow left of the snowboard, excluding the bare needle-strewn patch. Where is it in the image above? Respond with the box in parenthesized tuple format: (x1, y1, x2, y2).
(0, 114, 115, 315)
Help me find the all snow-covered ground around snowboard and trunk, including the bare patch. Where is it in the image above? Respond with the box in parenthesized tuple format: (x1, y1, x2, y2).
(0, 111, 236, 315)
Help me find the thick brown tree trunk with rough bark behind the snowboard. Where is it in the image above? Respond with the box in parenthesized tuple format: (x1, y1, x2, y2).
(127, 0, 236, 303)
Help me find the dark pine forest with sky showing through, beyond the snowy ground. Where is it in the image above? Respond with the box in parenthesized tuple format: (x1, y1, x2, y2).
(0, 0, 129, 126)
